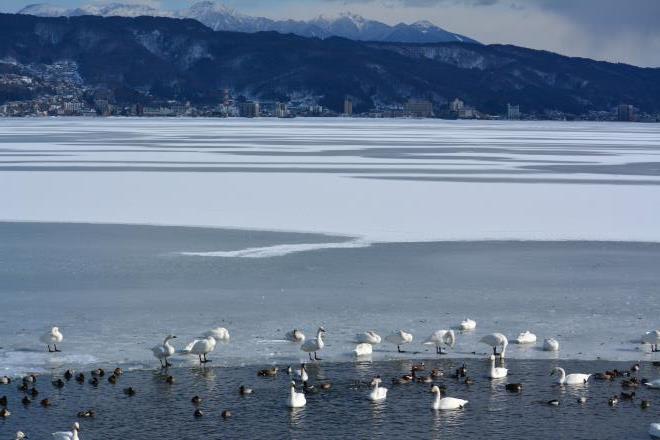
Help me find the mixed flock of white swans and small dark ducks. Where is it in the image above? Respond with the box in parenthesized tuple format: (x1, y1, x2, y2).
(0, 319, 660, 440)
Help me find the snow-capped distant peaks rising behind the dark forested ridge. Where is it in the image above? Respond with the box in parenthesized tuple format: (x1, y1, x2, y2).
(19, 1, 477, 43)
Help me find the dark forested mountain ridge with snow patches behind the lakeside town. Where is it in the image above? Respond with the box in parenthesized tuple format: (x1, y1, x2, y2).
(0, 14, 660, 113)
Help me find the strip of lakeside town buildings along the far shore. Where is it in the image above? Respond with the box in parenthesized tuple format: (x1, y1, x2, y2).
(0, 88, 660, 122)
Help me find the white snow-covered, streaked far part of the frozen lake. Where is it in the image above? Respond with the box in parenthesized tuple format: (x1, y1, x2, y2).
(0, 119, 660, 242)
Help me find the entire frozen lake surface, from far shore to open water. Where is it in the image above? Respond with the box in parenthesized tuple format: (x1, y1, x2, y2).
(0, 119, 660, 373)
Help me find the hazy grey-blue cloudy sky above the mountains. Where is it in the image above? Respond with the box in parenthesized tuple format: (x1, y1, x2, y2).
(5, 0, 660, 66)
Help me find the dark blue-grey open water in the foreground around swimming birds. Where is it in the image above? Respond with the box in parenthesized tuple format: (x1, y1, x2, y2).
(0, 359, 660, 440)
